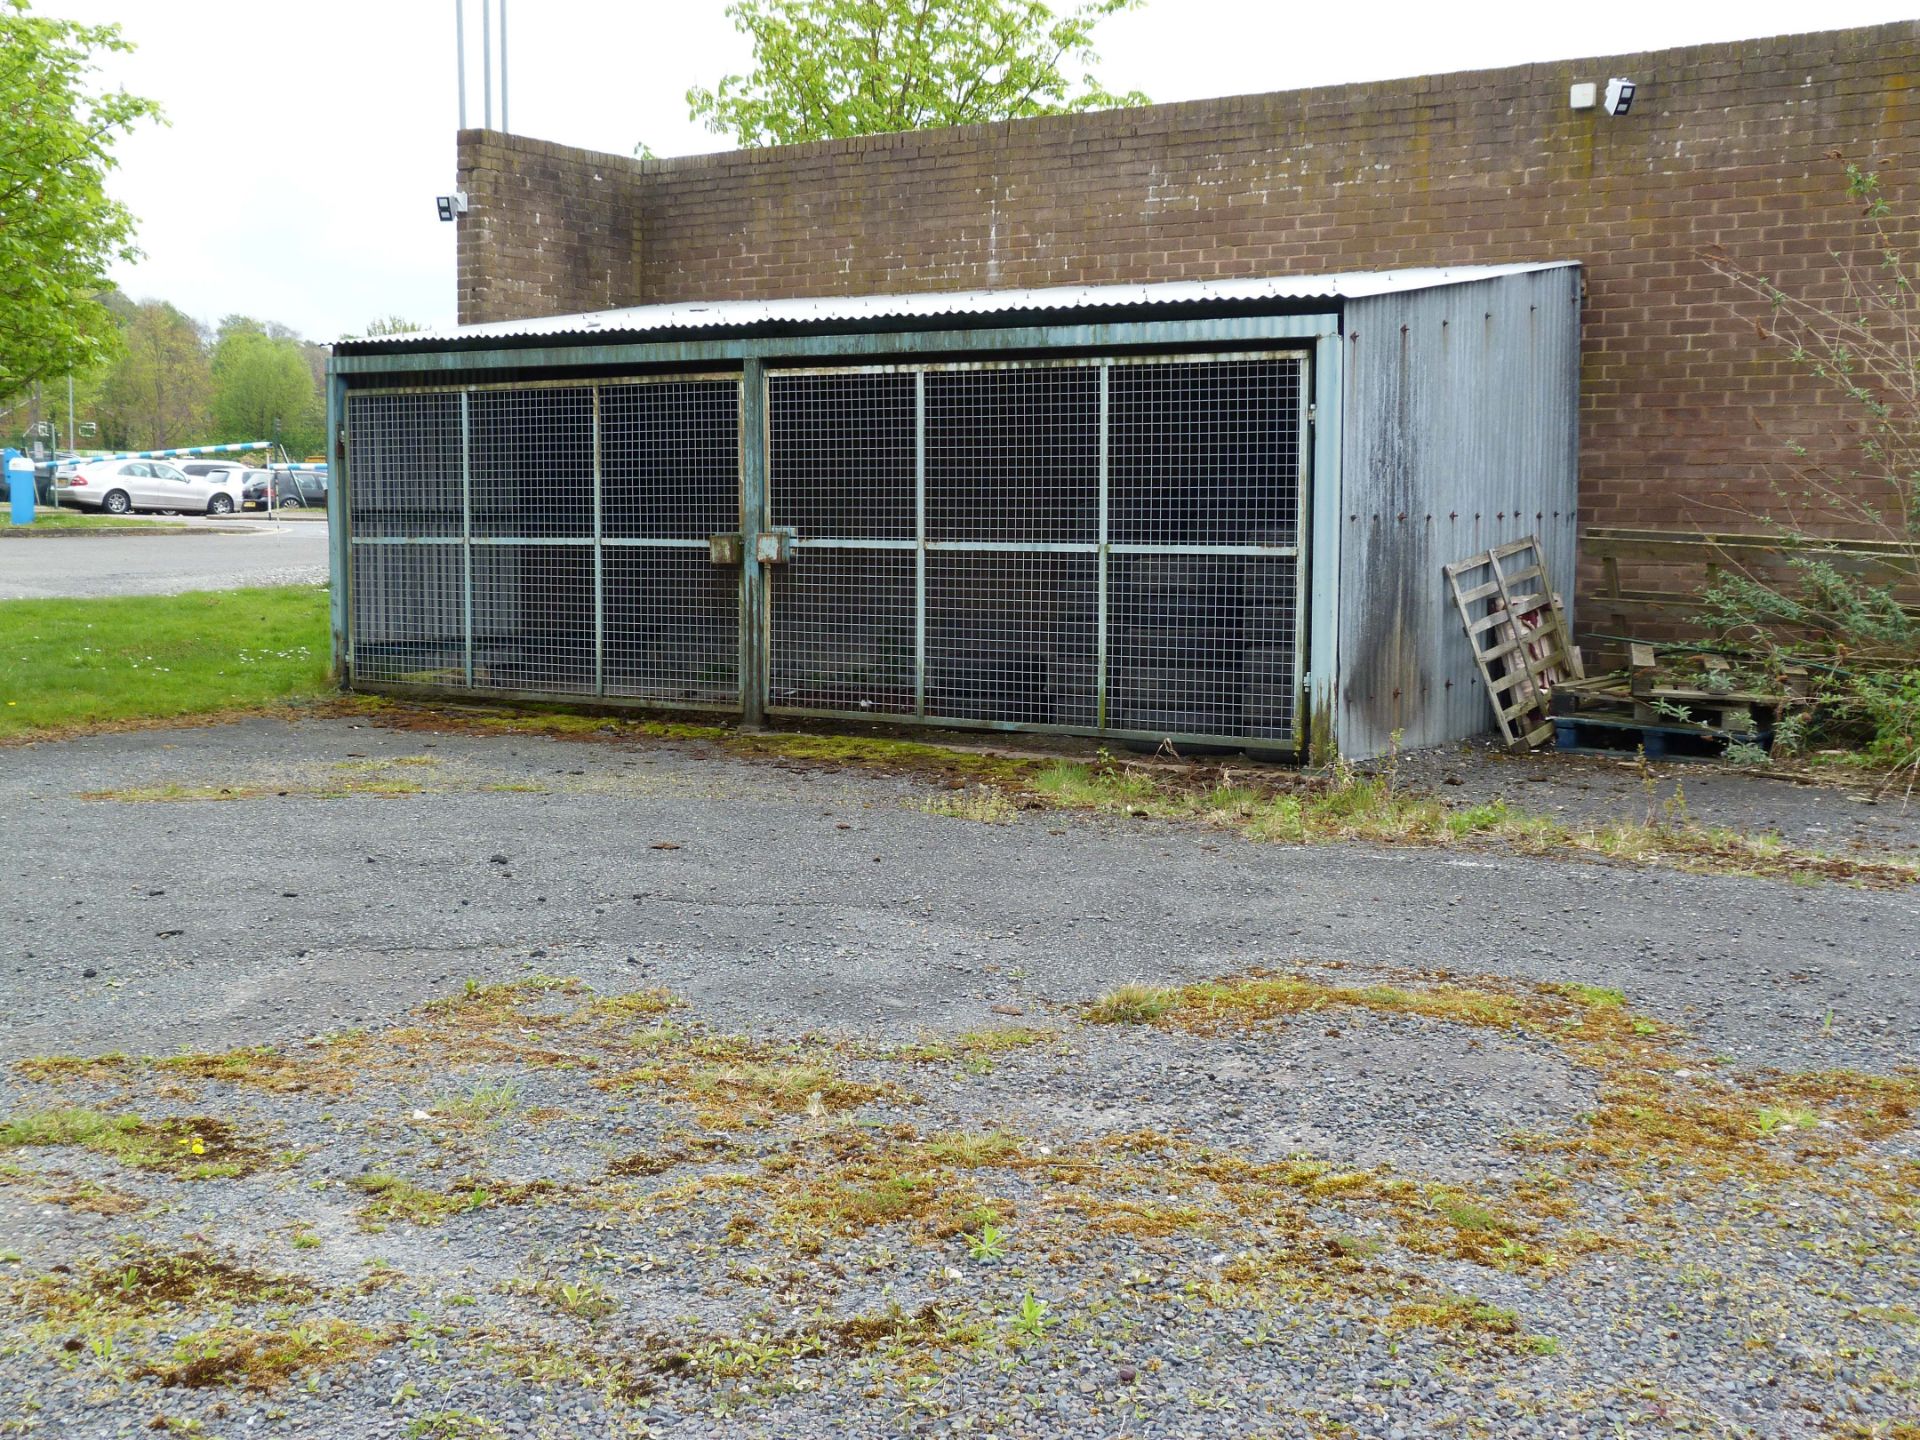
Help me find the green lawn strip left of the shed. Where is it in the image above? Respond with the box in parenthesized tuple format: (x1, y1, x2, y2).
(0, 586, 330, 739)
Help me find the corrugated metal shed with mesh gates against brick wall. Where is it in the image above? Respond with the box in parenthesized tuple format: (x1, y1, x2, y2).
(328, 263, 1580, 758)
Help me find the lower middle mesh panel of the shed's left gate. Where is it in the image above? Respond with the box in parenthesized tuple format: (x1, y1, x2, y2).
(472, 545, 593, 695)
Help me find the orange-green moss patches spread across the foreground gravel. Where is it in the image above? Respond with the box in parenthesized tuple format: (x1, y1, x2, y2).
(0, 968, 1920, 1428)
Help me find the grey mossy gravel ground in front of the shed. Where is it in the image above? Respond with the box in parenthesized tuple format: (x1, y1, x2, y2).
(0, 721, 1920, 1440)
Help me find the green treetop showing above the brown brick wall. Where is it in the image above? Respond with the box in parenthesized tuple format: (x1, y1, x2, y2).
(687, 0, 1148, 146)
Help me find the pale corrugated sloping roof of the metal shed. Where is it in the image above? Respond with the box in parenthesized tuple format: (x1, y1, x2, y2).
(340, 261, 1574, 349)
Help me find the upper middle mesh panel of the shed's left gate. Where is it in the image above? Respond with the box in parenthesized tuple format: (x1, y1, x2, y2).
(468, 386, 593, 540)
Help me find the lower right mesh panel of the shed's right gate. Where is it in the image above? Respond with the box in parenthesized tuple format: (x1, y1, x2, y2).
(1108, 555, 1298, 739)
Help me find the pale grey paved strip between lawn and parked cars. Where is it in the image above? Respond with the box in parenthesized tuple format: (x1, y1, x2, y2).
(0, 516, 328, 601)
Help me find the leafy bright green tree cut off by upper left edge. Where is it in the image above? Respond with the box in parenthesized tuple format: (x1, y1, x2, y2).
(0, 0, 159, 396)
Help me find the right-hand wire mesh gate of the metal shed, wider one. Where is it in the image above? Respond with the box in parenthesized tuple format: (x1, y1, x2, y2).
(766, 353, 1308, 749)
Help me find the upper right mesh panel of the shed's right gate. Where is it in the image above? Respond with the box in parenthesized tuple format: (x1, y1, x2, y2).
(1108, 359, 1302, 545)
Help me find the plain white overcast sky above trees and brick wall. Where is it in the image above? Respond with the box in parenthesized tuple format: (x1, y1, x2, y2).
(35, 0, 1912, 340)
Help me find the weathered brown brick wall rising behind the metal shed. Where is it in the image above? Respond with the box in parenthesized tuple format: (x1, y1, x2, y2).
(459, 21, 1920, 545)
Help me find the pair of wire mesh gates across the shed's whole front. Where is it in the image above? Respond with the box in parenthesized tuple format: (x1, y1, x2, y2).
(346, 351, 1308, 749)
